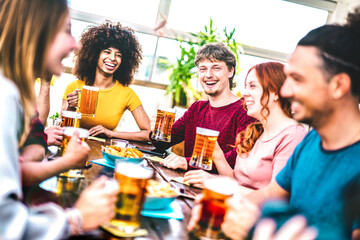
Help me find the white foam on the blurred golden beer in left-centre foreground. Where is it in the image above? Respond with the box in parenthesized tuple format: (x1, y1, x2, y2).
(115, 160, 154, 179)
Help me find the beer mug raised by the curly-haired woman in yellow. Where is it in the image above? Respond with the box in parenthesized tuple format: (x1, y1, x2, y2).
(79, 86, 99, 117)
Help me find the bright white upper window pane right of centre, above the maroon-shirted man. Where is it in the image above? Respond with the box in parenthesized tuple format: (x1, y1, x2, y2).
(168, 0, 328, 53)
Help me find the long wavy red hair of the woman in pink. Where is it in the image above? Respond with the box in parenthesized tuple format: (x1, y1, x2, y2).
(235, 62, 291, 154)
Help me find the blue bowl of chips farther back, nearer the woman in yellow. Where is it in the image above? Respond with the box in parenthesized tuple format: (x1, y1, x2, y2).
(101, 145, 144, 165)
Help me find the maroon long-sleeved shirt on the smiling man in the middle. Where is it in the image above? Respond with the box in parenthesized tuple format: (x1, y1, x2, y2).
(153, 100, 256, 173)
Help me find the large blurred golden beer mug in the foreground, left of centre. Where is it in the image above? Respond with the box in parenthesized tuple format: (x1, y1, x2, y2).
(110, 160, 154, 233)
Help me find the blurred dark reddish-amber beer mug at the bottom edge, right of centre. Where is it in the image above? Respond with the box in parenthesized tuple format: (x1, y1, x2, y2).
(194, 177, 238, 239)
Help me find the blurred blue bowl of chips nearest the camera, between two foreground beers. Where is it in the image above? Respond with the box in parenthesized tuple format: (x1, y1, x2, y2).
(143, 179, 179, 210)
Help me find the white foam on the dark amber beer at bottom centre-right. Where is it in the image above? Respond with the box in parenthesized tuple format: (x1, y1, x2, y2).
(204, 177, 238, 196)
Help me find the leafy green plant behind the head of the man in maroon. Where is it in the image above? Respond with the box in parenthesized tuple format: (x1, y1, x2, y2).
(158, 18, 243, 107)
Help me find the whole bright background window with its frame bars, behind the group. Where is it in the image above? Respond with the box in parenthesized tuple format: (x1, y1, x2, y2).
(65, 0, 329, 85)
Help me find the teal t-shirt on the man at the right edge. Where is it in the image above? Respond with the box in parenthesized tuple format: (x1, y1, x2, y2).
(276, 130, 360, 239)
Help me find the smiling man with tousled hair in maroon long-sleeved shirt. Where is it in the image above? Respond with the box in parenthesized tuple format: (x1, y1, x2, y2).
(152, 43, 255, 182)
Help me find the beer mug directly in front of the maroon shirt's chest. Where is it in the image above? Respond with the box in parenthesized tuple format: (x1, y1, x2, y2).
(189, 127, 219, 170)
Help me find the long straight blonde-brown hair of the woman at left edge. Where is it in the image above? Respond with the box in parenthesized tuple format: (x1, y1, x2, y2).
(0, 0, 69, 145)
